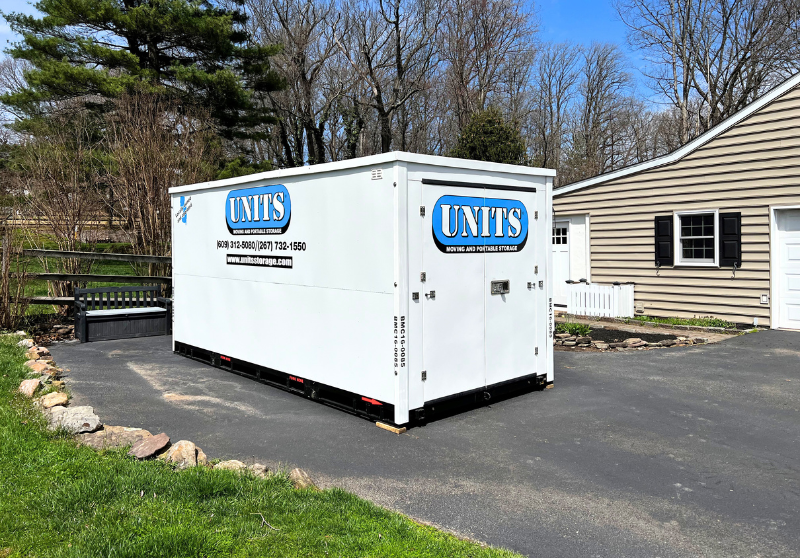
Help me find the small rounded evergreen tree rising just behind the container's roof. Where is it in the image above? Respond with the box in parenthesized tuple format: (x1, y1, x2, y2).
(450, 107, 527, 165)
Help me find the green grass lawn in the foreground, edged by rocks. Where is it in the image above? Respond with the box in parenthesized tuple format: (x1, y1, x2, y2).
(0, 336, 517, 558)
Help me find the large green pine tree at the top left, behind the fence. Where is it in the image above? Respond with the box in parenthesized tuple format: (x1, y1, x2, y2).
(0, 0, 281, 138)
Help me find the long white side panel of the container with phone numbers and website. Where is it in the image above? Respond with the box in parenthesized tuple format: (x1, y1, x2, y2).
(173, 165, 395, 402)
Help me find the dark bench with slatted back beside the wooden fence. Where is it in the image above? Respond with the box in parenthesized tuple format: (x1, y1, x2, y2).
(75, 287, 172, 343)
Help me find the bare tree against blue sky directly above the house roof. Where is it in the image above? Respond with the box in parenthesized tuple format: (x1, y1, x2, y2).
(616, 0, 800, 143)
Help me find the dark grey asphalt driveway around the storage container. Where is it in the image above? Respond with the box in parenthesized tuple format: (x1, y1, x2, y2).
(50, 331, 800, 557)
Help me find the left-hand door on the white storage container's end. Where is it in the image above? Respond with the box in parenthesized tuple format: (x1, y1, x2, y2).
(419, 182, 486, 402)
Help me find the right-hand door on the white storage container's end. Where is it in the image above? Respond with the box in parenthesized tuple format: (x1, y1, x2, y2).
(483, 189, 536, 386)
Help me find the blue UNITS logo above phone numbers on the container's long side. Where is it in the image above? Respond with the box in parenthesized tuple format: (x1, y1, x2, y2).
(225, 184, 292, 235)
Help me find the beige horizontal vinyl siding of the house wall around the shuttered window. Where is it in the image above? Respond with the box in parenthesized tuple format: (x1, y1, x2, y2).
(553, 88, 800, 325)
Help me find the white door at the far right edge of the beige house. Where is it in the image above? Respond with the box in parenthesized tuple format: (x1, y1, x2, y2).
(775, 209, 800, 329)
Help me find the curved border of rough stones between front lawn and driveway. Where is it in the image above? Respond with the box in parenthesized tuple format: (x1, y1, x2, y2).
(11, 332, 317, 490)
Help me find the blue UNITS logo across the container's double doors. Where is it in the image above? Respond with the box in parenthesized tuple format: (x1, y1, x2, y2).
(432, 196, 528, 254)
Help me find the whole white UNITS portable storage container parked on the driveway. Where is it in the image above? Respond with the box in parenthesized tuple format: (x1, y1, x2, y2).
(170, 152, 555, 425)
